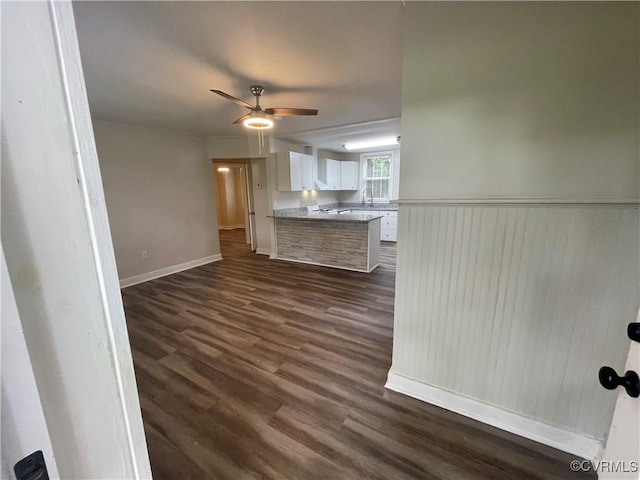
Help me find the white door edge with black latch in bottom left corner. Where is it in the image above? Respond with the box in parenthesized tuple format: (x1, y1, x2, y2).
(0, 248, 60, 479)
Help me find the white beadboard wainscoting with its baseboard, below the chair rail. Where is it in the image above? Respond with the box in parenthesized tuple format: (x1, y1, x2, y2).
(387, 202, 640, 459)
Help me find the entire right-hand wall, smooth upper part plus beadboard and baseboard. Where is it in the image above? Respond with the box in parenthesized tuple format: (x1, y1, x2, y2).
(389, 2, 640, 458)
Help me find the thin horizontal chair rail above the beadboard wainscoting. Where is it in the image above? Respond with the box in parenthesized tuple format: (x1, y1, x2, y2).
(390, 197, 640, 207)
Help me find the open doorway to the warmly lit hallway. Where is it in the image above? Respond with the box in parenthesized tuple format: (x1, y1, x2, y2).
(213, 160, 256, 257)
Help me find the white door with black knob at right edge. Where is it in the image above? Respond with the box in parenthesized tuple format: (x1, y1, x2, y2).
(595, 312, 640, 480)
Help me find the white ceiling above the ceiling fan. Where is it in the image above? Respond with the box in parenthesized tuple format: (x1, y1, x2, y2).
(74, 1, 402, 150)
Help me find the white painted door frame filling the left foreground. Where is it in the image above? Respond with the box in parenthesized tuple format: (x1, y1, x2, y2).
(0, 1, 151, 479)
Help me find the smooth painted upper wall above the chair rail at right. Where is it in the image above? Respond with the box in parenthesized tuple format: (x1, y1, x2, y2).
(400, 2, 640, 199)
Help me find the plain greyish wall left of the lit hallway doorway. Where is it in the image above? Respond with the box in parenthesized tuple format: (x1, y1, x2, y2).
(94, 120, 220, 281)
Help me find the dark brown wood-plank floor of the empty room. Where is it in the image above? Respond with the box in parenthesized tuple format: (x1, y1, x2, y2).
(123, 230, 595, 480)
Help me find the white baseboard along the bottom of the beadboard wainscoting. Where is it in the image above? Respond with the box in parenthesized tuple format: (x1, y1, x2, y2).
(385, 371, 603, 461)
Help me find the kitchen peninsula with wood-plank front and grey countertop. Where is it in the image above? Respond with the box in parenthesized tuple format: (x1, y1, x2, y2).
(272, 212, 382, 273)
